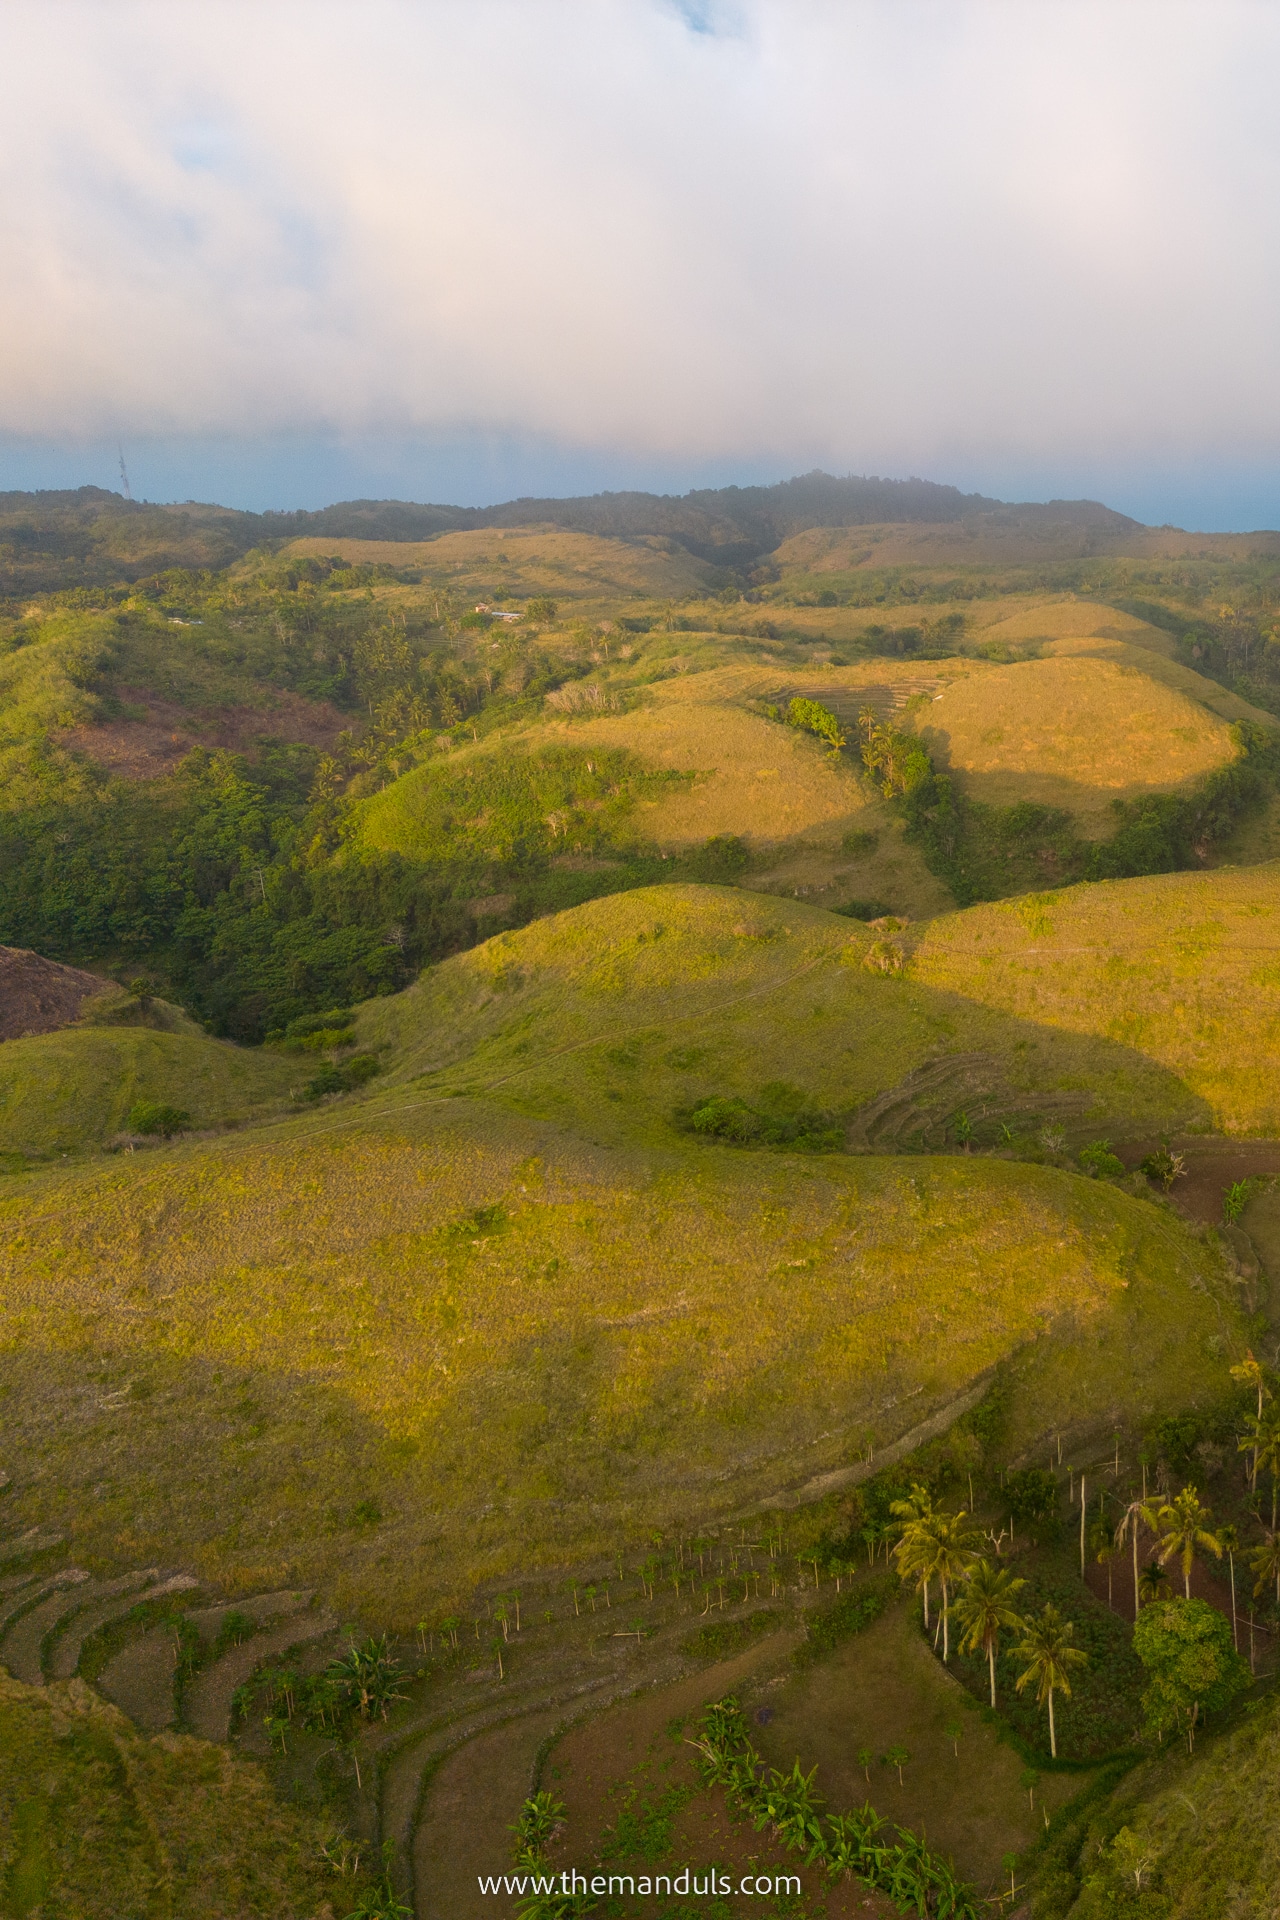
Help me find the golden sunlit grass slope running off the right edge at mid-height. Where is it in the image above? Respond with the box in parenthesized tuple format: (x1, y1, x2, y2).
(910, 862, 1280, 1135)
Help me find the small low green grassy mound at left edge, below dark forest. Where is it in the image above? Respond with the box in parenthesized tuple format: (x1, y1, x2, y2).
(0, 1027, 297, 1160)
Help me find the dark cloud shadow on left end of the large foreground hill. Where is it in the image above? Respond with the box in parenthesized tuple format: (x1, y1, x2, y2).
(0, 1340, 422, 1597)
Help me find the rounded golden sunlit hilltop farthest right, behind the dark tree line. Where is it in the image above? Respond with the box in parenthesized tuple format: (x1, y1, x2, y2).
(919, 649, 1240, 837)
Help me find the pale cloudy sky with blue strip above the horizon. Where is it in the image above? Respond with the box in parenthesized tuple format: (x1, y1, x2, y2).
(0, 0, 1280, 526)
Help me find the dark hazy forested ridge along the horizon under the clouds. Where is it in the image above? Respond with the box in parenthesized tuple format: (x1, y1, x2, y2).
(0, 472, 1142, 591)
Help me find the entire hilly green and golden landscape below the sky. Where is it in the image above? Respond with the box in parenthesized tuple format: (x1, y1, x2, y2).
(0, 474, 1280, 1920)
